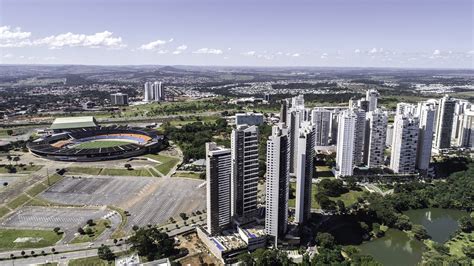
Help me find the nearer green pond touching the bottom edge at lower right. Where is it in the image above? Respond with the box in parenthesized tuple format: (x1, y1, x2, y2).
(358, 229, 424, 266)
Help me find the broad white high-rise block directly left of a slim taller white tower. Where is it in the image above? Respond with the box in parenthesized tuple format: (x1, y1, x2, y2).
(390, 114, 419, 174)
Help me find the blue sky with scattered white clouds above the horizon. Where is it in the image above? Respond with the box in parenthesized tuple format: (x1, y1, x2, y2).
(0, 0, 474, 69)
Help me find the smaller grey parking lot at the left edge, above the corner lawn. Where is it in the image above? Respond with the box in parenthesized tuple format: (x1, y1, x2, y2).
(0, 206, 110, 229)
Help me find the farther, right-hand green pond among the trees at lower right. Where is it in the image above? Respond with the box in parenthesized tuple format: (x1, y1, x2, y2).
(404, 208, 468, 243)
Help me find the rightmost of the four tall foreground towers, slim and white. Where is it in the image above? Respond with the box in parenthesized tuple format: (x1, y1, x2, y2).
(295, 122, 314, 223)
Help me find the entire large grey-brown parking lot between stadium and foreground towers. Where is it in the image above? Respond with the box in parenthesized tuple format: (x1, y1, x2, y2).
(40, 176, 206, 230)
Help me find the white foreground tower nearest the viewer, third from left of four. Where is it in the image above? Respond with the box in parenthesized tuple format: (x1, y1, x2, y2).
(265, 123, 290, 244)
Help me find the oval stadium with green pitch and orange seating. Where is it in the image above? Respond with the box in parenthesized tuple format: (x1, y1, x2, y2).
(27, 119, 163, 162)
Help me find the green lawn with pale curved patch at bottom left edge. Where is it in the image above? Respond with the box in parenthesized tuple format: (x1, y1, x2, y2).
(0, 229, 62, 250)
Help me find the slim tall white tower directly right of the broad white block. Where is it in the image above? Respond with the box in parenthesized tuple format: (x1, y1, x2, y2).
(416, 102, 436, 172)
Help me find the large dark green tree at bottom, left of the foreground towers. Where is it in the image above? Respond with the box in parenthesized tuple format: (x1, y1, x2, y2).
(127, 227, 175, 261)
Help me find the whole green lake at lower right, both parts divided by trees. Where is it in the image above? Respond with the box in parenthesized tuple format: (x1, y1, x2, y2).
(358, 208, 468, 266)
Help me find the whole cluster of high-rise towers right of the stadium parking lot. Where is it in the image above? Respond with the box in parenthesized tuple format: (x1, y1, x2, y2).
(206, 90, 474, 245)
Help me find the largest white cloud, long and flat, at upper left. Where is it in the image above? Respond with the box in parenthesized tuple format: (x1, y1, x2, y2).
(33, 31, 126, 49)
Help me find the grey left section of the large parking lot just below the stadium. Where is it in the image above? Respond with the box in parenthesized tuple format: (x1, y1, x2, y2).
(40, 176, 154, 205)
